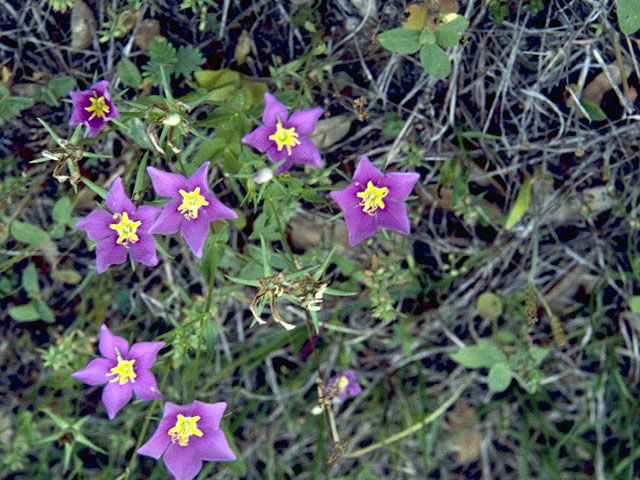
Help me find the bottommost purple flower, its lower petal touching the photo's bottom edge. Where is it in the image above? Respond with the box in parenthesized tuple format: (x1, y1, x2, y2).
(138, 400, 236, 480)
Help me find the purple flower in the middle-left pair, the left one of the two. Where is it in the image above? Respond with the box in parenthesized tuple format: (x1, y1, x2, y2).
(76, 177, 160, 273)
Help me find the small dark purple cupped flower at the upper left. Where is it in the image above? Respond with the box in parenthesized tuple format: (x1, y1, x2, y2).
(69, 80, 120, 138)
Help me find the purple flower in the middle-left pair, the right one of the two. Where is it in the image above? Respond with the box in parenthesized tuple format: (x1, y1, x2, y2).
(147, 162, 238, 258)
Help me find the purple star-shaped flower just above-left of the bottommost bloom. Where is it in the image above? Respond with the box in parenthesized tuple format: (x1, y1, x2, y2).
(71, 325, 164, 420)
